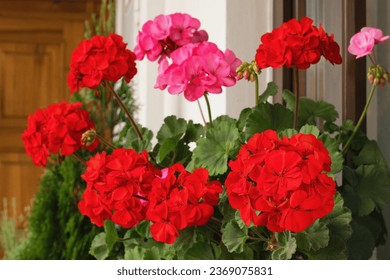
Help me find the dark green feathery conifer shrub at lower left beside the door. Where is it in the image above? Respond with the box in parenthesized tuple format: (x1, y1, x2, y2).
(13, 158, 100, 260)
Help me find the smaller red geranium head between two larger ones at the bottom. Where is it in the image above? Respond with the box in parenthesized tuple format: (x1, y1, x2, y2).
(146, 164, 222, 244)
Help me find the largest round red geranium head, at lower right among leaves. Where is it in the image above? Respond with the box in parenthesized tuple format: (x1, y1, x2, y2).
(225, 130, 336, 232)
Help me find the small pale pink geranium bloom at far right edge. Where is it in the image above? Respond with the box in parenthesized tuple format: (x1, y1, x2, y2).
(348, 27, 390, 58)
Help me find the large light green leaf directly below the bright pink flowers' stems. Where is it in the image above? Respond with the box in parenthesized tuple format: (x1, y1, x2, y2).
(192, 116, 240, 176)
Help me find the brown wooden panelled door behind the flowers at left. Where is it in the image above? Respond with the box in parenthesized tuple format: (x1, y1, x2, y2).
(0, 0, 100, 236)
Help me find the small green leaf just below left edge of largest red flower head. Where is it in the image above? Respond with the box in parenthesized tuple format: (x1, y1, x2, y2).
(222, 221, 248, 253)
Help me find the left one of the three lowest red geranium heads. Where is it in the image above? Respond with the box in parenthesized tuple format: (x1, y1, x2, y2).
(79, 149, 160, 228)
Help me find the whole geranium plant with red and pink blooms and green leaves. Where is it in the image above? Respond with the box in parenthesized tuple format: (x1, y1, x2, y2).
(22, 13, 390, 259)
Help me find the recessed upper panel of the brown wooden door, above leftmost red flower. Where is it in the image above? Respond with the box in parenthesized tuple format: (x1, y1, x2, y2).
(0, 43, 66, 122)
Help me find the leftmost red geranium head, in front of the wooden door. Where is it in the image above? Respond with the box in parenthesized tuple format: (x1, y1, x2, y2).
(22, 102, 98, 166)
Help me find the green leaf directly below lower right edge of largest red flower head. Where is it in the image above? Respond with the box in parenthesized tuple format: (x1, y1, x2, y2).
(296, 220, 329, 251)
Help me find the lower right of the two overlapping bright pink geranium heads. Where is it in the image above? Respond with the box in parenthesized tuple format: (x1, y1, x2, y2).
(155, 42, 241, 101)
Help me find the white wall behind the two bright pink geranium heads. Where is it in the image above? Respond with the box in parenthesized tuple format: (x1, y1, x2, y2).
(116, 0, 273, 133)
